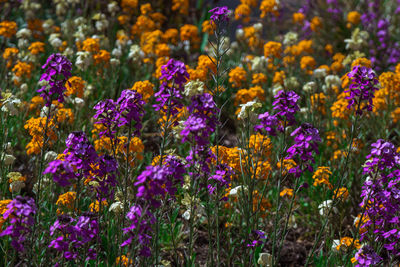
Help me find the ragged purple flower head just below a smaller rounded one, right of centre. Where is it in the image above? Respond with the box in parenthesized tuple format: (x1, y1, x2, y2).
(286, 123, 321, 177)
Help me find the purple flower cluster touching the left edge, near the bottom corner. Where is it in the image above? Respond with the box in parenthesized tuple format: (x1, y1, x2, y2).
(0, 196, 36, 252)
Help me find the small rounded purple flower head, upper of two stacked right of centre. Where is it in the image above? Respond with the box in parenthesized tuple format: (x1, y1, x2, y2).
(272, 90, 300, 127)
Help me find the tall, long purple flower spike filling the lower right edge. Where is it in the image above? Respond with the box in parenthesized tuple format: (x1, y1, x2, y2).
(356, 140, 400, 266)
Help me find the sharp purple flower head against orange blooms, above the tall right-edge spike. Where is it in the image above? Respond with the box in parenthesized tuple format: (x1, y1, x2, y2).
(344, 65, 378, 115)
